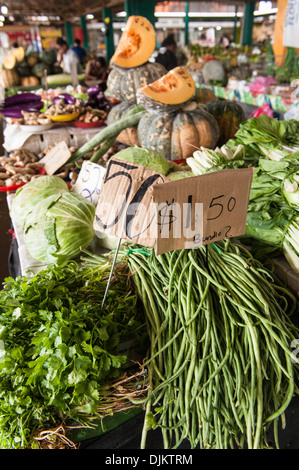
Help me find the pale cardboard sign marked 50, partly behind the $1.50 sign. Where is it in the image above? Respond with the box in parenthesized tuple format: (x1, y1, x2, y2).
(93, 158, 169, 248)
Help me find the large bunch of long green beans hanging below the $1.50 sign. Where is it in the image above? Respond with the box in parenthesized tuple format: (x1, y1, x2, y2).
(123, 240, 299, 449)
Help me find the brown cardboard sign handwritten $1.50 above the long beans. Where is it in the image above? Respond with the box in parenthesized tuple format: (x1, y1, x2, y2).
(153, 168, 254, 254)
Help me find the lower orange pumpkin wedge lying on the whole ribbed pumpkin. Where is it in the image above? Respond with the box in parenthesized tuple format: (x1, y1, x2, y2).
(139, 67, 195, 105)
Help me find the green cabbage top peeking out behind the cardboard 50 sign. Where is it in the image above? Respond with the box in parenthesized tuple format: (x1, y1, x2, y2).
(113, 145, 169, 176)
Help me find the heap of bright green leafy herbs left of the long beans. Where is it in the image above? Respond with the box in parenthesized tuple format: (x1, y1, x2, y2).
(0, 260, 145, 449)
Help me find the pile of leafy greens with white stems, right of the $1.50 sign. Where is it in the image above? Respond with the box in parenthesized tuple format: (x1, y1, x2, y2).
(187, 115, 299, 273)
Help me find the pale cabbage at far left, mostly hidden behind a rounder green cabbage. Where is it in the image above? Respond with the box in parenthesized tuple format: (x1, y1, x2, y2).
(10, 175, 69, 226)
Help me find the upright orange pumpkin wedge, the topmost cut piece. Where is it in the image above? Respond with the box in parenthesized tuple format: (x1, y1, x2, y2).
(110, 15, 156, 68)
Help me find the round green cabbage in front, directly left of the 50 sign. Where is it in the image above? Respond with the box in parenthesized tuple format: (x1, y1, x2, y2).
(24, 192, 95, 264)
